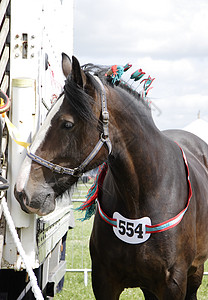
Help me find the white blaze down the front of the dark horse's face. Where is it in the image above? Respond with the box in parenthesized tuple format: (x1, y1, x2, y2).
(16, 95, 64, 192)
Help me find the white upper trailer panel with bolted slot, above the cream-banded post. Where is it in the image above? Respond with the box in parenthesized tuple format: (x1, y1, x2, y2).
(10, 0, 43, 79)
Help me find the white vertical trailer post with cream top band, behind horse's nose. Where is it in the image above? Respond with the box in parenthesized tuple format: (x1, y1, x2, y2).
(3, 79, 36, 268)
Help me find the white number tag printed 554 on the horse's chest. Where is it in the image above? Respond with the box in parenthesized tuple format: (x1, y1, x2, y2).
(113, 212, 151, 244)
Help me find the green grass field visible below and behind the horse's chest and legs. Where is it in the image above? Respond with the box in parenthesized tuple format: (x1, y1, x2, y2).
(54, 184, 208, 300)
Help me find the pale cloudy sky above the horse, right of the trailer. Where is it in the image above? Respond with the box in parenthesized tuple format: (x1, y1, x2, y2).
(74, 0, 208, 129)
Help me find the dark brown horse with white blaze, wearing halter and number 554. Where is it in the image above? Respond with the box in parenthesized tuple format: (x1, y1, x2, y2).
(14, 54, 208, 300)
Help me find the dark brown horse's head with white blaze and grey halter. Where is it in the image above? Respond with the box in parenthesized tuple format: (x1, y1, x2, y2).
(15, 54, 110, 215)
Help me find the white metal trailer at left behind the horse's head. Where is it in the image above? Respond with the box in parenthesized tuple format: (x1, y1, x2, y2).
(0, 0, 74, 300)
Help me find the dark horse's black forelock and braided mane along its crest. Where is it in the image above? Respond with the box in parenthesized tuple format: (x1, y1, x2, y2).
(64, 64, 149, 121)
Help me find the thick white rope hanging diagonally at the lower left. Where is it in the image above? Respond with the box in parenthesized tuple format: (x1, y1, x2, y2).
(1, 197, 44, 300)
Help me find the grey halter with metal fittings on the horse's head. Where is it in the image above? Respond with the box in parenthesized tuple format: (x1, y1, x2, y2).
(27, 76, 112, 177)
